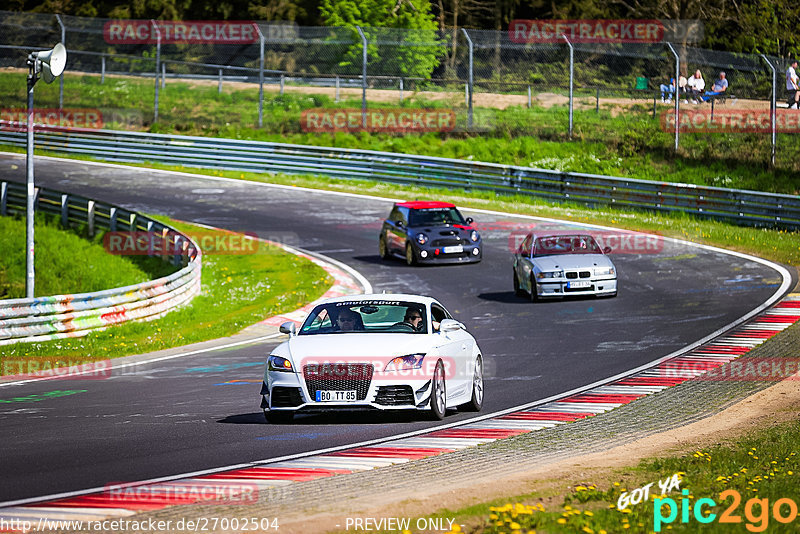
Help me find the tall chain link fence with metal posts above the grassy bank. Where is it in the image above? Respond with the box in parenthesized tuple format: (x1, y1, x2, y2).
(0, 11, 800, 169)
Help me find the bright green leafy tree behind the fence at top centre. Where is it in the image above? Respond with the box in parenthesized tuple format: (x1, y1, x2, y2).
(320, 0, 444, 78)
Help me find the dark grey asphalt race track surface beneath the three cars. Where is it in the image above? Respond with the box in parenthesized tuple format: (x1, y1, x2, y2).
(0, 155, 781, 502)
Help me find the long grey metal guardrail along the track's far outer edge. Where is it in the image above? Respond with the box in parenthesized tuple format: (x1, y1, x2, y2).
(0, 126, 800, 230)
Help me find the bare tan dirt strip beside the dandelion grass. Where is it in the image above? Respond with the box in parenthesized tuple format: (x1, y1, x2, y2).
(281, 380, 800, 533)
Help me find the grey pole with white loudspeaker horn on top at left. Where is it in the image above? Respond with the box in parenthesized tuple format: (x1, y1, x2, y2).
(25, 43, 67, 299)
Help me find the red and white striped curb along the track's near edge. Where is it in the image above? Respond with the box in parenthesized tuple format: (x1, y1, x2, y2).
(0, 298, 800, 524)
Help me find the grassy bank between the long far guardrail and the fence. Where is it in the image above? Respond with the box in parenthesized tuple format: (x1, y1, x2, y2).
(0, 73, 800, 194)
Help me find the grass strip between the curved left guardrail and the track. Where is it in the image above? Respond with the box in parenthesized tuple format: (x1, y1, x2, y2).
(0, 217, 332, 365)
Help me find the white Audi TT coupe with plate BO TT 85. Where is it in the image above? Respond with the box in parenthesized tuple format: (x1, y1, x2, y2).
(261, 294, 483, 423)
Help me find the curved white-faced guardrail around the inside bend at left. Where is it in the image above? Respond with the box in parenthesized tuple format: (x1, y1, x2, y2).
(0, 182, 202, 346)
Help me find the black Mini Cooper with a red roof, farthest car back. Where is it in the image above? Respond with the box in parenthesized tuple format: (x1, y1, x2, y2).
(378, 201, 483, 265)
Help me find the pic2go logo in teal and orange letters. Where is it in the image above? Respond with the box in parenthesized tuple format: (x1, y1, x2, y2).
(653, 490, 797, 532)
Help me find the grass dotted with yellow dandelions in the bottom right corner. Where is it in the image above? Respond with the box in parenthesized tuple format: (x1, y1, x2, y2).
(412, 422, 800, 534)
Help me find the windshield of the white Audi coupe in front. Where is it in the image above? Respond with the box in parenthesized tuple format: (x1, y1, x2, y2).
(298, 300, 427, 336)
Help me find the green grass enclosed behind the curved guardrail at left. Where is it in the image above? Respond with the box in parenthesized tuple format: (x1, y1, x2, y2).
(0, 217, 175, 299)
